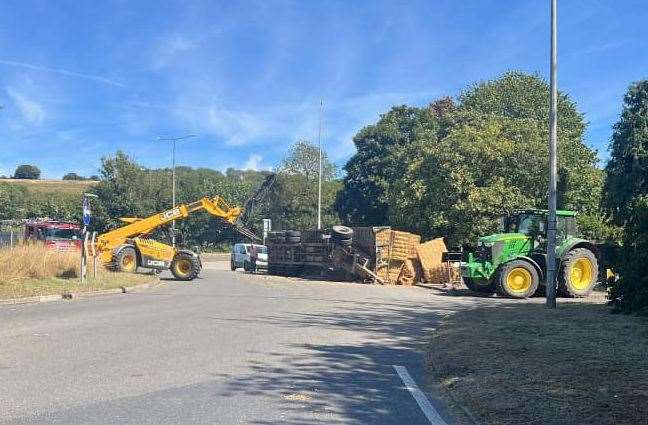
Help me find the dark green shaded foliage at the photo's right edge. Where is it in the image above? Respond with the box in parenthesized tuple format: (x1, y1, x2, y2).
(604, 80, 648, 313)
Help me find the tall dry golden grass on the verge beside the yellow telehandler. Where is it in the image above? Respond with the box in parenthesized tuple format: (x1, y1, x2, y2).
(0, 245, 154, 299)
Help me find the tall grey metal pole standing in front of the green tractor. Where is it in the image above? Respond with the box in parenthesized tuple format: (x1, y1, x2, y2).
(546, 0, 558, 308)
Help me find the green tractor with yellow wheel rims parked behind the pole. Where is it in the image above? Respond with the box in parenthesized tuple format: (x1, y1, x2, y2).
(461, 210, 599, 298)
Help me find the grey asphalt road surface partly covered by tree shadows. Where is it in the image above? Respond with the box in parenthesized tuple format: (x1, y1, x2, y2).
(0, 263, 470, 425)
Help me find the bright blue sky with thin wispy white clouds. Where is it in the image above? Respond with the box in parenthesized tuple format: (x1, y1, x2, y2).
(0, 0, 648, 178)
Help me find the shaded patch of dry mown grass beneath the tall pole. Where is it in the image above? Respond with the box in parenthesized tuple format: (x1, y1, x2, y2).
(430, 302, 648, 424)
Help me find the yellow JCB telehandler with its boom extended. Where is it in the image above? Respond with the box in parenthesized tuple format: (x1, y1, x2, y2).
(96, 196, 258, 280)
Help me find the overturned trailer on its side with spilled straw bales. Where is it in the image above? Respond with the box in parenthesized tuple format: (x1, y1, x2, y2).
(266, 226, 428, 284)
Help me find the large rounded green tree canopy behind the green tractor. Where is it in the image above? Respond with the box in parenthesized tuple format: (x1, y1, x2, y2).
(336, 73, 610, 245)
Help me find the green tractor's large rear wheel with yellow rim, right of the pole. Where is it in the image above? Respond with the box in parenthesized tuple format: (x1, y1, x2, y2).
(558, 248, 598, 297)
